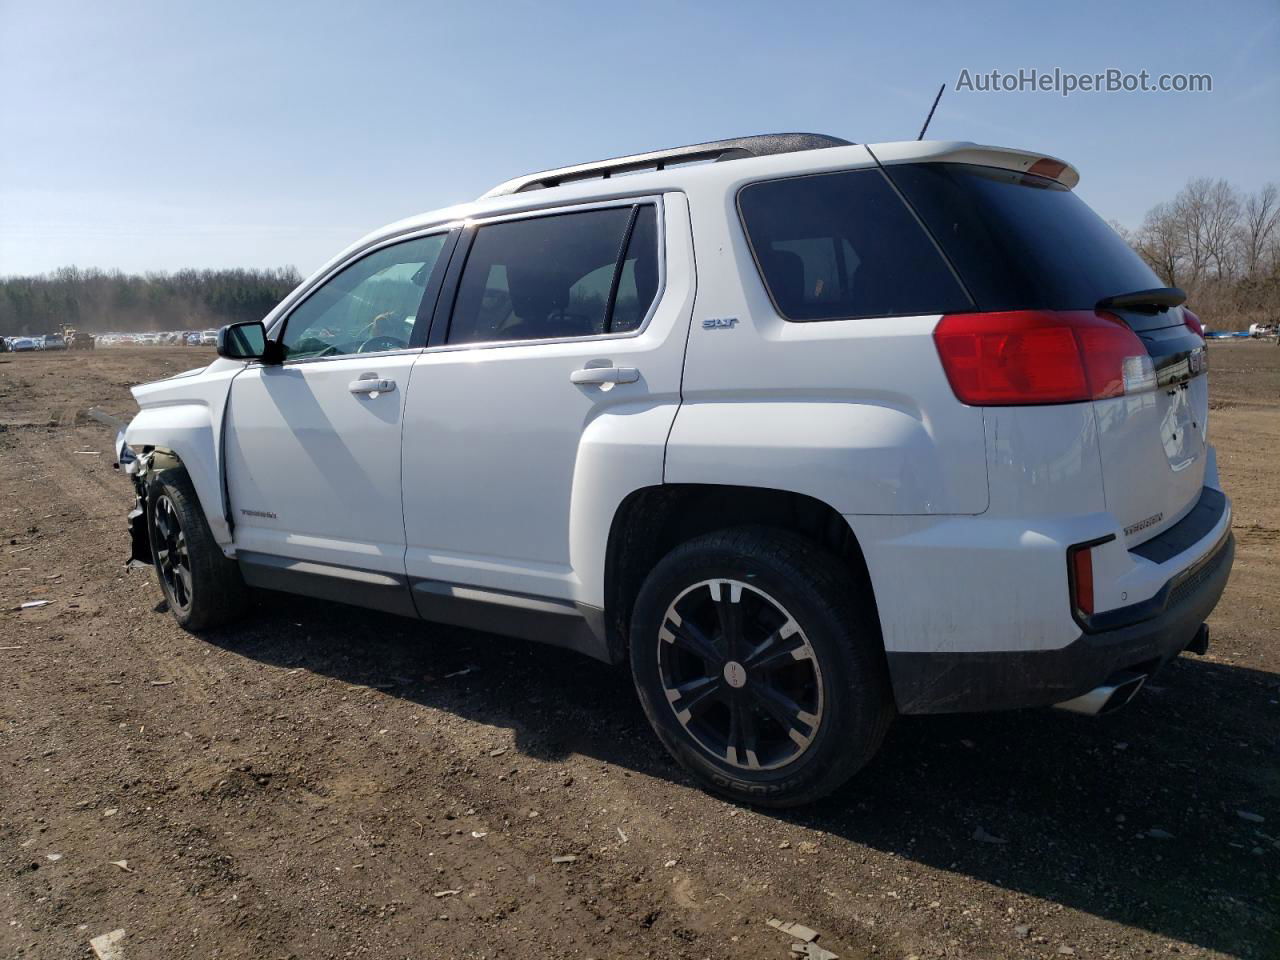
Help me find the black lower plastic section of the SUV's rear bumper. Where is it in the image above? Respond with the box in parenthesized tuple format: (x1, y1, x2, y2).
(887, 531, 1235, 713)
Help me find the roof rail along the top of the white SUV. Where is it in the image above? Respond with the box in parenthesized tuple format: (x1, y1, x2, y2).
(484, 133, 852, 197)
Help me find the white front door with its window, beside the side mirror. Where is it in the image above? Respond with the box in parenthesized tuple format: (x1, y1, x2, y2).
(225, 233, 447, 609)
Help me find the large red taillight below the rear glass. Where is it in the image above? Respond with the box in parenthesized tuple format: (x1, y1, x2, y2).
(933, 310, 1156, 407)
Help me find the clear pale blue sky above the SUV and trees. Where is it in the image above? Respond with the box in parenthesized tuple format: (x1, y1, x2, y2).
(0, 0, 1280, 274)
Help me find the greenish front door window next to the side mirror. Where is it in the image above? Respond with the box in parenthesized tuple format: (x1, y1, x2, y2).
(280, 233, 448, 360)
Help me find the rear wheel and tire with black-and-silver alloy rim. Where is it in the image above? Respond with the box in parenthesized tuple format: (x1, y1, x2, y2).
(630, 527, 895, 808)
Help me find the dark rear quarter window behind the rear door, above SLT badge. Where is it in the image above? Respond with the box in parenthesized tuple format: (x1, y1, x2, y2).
(739, 170, 972, 320)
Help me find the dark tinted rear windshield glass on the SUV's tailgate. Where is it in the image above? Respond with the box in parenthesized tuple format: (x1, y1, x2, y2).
(888, 164, 1165, 310)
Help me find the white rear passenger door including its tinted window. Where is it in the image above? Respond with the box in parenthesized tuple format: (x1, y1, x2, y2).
(403, 195, 692, 603)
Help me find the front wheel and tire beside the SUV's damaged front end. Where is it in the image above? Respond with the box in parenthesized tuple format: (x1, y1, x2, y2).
(147, 470, 248, 630)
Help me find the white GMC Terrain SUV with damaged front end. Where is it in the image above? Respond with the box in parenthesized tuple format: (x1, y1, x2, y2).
(123, 134, 1233, 805)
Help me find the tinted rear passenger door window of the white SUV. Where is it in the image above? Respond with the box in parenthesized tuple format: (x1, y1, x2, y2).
(448, 204, 658, 343)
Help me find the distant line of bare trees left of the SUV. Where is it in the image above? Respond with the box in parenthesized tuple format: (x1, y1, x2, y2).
(0, 266, 302, 337)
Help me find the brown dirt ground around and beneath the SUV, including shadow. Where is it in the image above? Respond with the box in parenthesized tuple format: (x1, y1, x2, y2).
(0, 343, 1280, 960)
